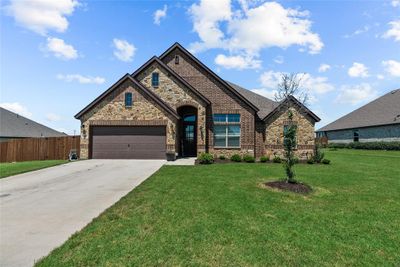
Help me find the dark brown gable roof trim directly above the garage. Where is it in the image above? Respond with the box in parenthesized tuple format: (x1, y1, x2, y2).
(75, 73, 180, 119)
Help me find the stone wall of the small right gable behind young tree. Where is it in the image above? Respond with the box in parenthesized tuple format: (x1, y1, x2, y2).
(264, 105, 315, 159)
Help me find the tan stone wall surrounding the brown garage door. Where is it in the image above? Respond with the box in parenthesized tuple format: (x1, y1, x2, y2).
(80, 80, 176, 158)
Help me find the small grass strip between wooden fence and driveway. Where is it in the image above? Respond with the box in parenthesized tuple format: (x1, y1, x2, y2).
(0, 160, 68, 178)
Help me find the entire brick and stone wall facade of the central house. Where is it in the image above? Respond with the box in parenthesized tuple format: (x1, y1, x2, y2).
(78, 43, 315, 159)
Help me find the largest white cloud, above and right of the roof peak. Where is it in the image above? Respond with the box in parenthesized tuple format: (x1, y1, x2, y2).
(189, 0, 324, 66)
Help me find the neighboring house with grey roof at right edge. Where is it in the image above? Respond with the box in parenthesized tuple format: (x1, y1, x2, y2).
(317, 89, 400, 143)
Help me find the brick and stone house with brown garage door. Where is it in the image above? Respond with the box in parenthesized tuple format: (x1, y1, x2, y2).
(75, 43, 320, 159)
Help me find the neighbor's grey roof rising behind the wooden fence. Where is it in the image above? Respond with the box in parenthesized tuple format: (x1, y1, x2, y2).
(0, 107, 66, 142)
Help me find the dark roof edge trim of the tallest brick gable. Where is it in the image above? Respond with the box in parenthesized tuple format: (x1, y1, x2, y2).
(159, 42, 259, 111)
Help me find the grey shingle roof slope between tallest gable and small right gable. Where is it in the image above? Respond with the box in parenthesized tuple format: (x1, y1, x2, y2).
(226, 81, 279, 119)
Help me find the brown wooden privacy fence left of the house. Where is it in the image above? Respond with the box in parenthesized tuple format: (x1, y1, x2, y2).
(0, 135, 80, 162)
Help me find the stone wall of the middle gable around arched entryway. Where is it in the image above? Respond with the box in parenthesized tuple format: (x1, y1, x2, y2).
(137, 63, 207, 154)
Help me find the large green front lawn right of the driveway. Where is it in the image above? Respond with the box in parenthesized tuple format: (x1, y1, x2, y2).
(37, 150, 400, 266)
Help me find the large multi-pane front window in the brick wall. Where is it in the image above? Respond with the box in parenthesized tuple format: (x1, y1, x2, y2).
(214, 114, 240, 148)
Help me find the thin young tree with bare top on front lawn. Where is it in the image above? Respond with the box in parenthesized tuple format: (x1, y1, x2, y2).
(275, 73, 308, 183)
